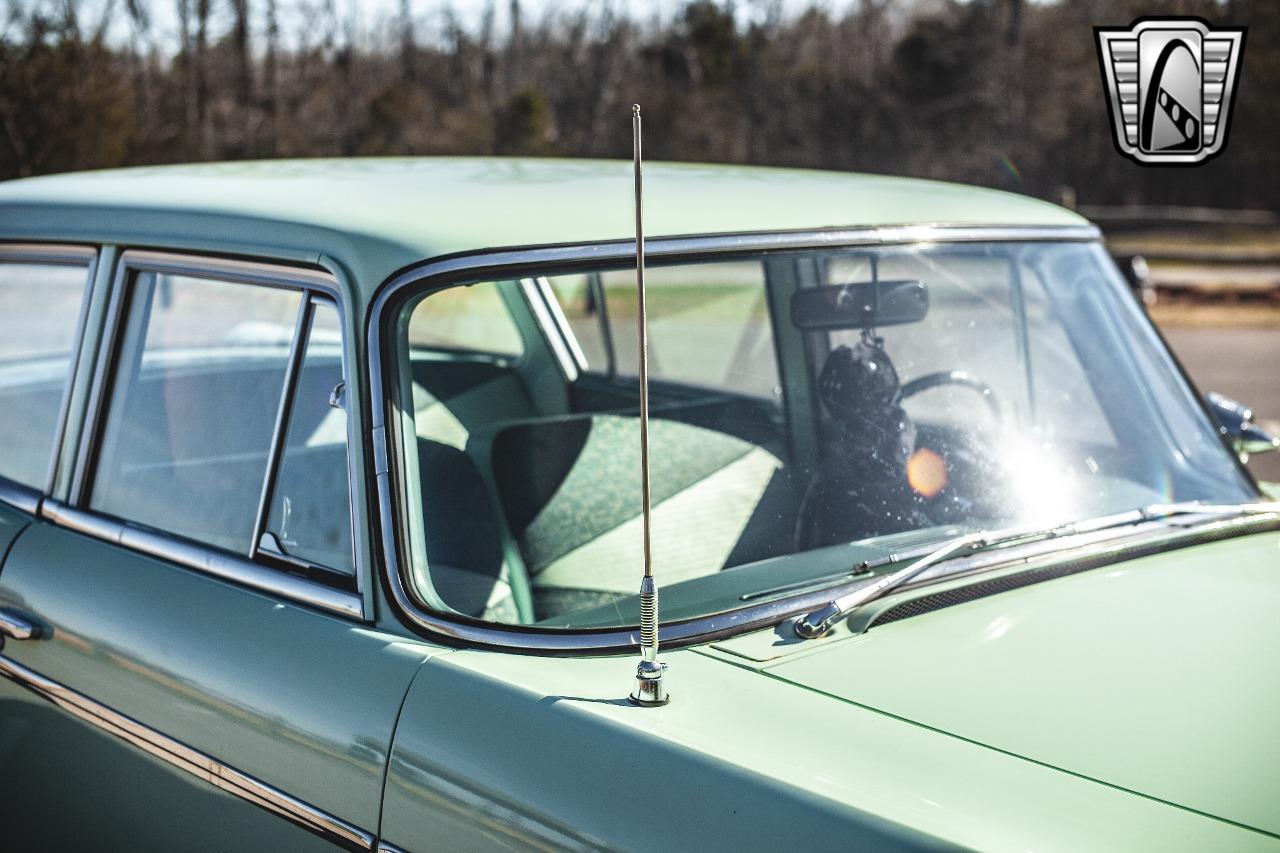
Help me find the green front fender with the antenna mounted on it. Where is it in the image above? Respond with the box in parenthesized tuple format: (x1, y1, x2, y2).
(383, 640, 1280, 850)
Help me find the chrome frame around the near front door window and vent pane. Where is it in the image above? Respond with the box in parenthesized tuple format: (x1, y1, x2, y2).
(42, 250, 370, 621)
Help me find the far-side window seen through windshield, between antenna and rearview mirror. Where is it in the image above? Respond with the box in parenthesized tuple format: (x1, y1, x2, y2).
(549, 260, 778, 398)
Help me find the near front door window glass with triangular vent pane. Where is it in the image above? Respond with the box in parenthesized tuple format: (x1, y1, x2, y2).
(88, 267, 352, 574)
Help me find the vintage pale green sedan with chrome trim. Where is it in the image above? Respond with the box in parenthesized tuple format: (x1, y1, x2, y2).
(0, 158, 1280, 853)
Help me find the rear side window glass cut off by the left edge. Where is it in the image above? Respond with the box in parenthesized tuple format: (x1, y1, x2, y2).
(0, 263, 88, 491)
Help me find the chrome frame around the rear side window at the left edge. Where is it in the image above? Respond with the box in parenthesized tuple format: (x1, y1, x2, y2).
(0, 242, 100, 515)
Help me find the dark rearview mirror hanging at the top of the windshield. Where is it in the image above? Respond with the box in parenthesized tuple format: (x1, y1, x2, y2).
(791, 280, 929, 332)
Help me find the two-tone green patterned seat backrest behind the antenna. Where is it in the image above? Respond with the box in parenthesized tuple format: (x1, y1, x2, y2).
(490, 415, 794, 619)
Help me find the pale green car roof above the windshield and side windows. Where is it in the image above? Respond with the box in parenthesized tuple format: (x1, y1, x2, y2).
(0, 158, 1085, 295)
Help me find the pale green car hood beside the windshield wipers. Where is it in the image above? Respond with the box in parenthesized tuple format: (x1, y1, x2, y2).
(764, 533, 1280, 834)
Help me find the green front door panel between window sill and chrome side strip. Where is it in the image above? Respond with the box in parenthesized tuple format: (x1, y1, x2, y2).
(0, 523, 430, 833)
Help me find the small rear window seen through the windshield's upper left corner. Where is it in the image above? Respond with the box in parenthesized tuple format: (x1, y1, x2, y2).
(410, 286, 525, 357)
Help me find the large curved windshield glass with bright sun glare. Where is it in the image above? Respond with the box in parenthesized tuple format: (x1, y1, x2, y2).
(398, 236, 1257, 628)
